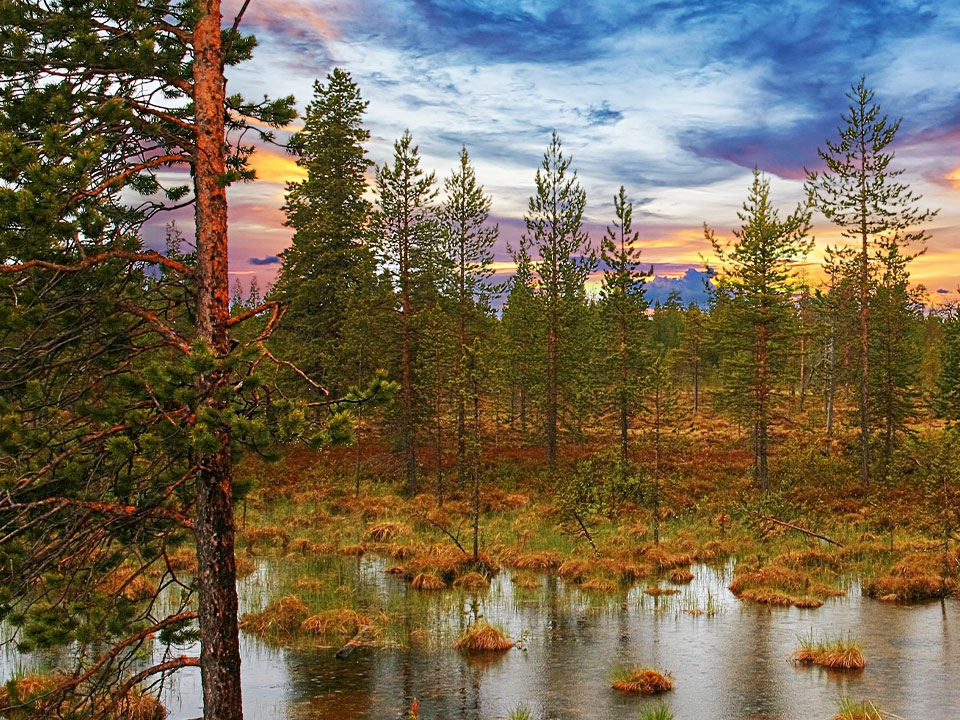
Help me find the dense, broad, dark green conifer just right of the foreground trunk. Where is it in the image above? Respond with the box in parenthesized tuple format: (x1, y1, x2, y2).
(273, 68, 376, 388)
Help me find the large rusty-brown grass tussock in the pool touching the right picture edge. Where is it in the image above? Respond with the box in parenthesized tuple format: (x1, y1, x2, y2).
(863, 552, 960, 602)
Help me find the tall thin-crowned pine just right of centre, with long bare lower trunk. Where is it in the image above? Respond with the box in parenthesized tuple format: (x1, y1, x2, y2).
(522, 131, 596, 469)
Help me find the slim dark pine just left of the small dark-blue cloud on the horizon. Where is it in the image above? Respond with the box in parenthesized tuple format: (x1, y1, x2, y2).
(600, 185, 650, 481)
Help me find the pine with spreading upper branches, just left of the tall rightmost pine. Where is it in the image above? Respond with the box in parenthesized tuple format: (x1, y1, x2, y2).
(704, 170, 812, 490)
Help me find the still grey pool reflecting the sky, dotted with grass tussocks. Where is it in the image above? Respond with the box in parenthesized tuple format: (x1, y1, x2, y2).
(156, 556, 960, 720)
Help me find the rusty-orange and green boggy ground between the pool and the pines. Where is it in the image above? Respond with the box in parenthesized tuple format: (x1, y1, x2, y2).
(231, 408, 960, 646)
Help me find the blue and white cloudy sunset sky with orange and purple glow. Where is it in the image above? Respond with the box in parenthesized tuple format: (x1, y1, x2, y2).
(148, 0, 960, 302)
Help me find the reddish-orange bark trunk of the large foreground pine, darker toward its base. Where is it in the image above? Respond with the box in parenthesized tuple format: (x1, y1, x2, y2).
(193, 0, 243, 720)
